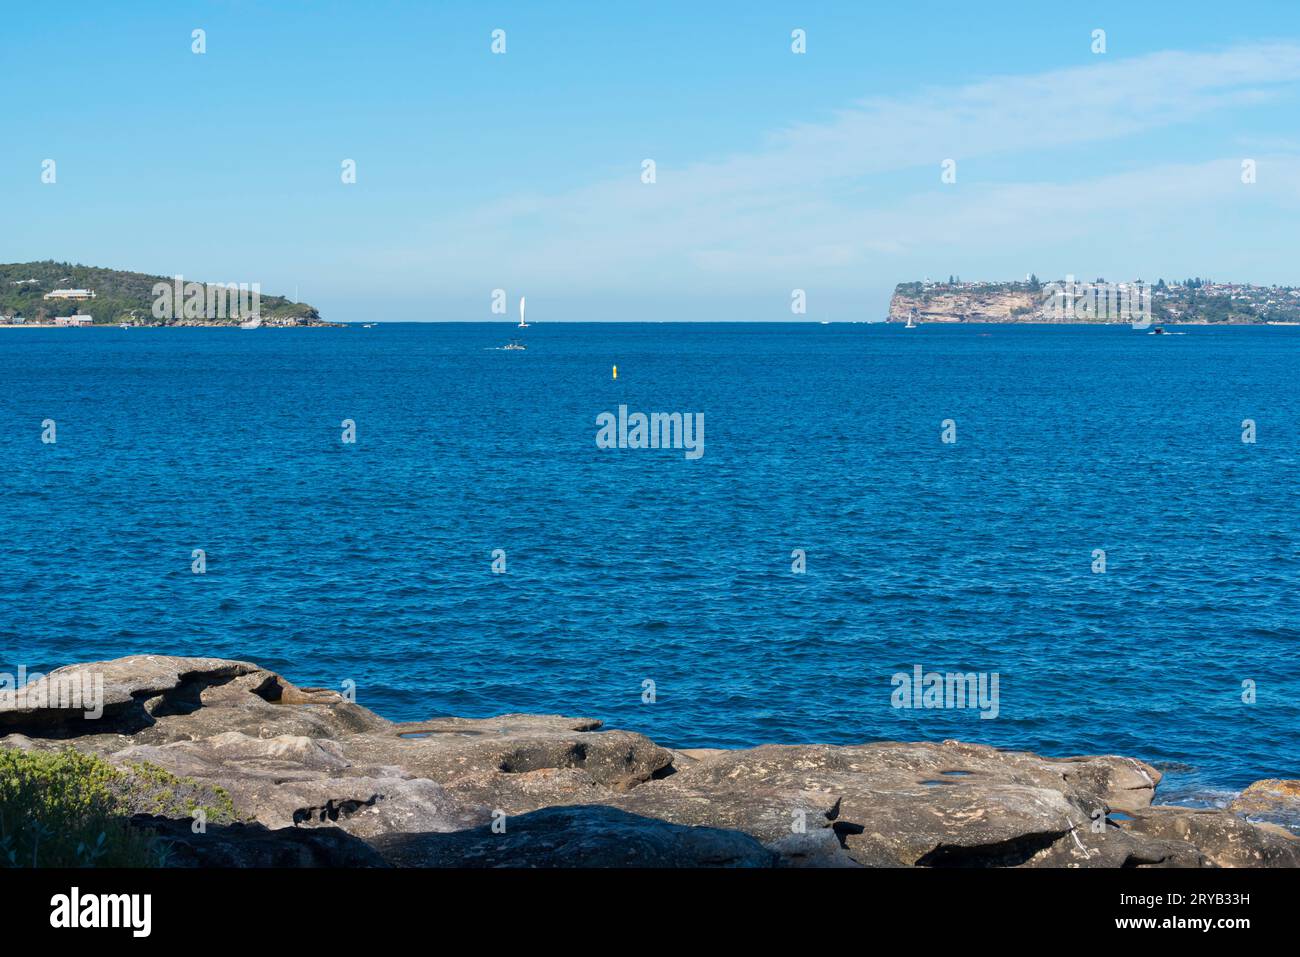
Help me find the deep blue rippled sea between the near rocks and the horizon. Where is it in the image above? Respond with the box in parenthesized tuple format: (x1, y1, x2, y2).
(0, 324, 1300, 800)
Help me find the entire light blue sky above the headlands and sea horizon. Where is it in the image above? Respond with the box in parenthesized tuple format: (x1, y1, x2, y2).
(0, 3, 1300, 321)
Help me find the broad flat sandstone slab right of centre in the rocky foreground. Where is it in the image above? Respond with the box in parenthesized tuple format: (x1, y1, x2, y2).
(615, 741, 1160, 867)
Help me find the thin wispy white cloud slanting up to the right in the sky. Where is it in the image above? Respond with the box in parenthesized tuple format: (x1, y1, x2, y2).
(385, 43, 1300, 302)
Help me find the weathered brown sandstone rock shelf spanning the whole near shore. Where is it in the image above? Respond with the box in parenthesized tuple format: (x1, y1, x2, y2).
(0, 655, 1300, 867)
